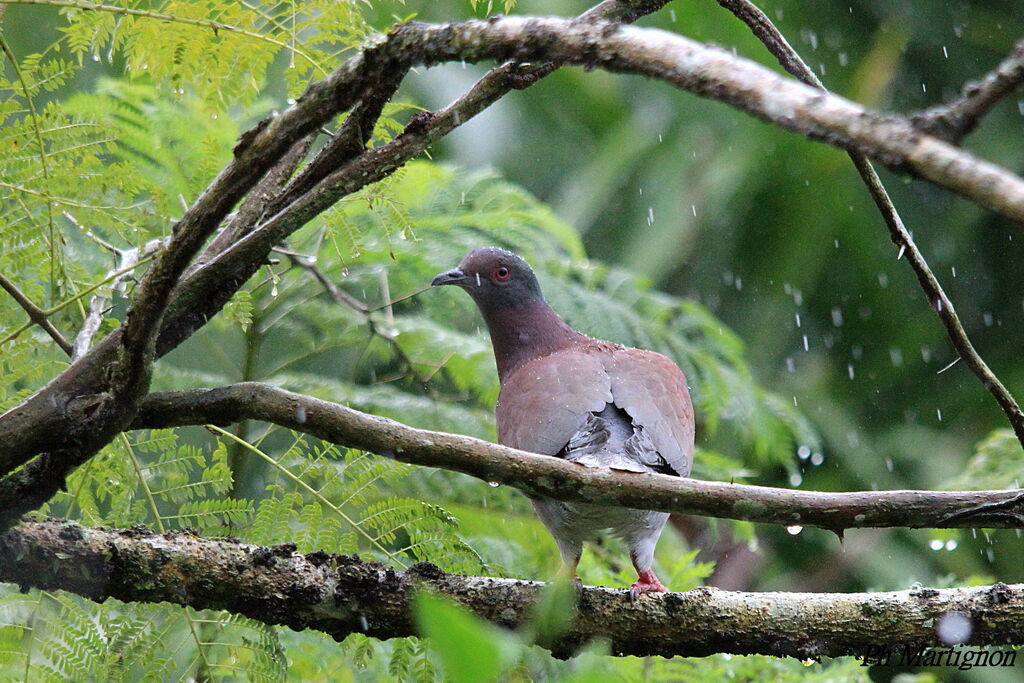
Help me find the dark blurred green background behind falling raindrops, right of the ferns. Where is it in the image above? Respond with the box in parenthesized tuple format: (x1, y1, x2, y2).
(2, 0, 1024, 680)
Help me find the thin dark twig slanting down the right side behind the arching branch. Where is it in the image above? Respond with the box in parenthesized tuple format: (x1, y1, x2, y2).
(718, 0, 1024, 446)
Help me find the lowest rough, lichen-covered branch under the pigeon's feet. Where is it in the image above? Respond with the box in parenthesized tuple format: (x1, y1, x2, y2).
(0, 520, 1024, 658)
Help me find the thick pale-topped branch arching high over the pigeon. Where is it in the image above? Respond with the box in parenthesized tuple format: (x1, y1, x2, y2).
(0, 12, 1024, 532)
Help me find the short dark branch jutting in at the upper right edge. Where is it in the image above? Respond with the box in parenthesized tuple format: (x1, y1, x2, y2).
(910, 40, 1024, 144)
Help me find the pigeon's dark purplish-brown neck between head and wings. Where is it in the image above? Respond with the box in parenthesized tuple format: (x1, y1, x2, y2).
(482, 301, 587, 381)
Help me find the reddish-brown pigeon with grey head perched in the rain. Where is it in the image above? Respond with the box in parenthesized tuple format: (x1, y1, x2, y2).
(430, 247, 694, 598)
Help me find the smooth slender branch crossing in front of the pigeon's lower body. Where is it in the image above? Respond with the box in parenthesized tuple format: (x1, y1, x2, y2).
(132, 382, 1024, 532)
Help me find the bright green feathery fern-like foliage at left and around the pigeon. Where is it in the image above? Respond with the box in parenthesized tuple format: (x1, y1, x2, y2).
(0, 0, 991, 681)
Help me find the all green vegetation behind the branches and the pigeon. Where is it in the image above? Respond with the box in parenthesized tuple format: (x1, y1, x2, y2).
(0, 0, 1024, 680)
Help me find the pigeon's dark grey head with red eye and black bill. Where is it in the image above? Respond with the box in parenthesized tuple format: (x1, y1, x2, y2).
(430, 247, 544, 311)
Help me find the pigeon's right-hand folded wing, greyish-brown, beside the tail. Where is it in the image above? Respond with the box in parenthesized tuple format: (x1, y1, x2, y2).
(603, 347, 693, 476)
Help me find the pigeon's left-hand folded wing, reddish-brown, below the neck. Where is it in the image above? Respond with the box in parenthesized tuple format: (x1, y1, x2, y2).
(495, 348, 611, 456)
